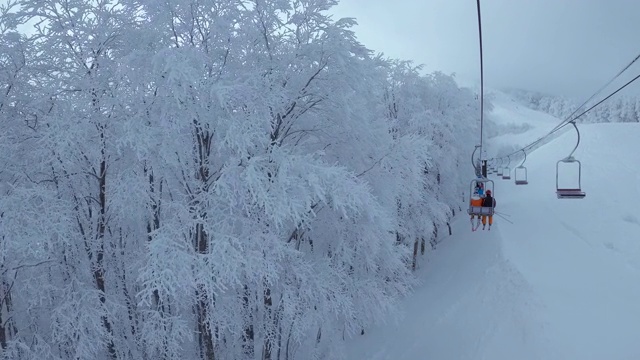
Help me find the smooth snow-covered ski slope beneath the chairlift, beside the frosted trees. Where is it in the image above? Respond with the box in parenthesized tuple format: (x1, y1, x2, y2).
(347, 94, 640, 360)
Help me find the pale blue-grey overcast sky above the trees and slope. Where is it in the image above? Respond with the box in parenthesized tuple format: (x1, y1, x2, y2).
(333, 0, 640, 98)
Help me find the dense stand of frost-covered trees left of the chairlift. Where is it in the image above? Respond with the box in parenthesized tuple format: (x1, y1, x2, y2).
(0, 0, 478, 359)
